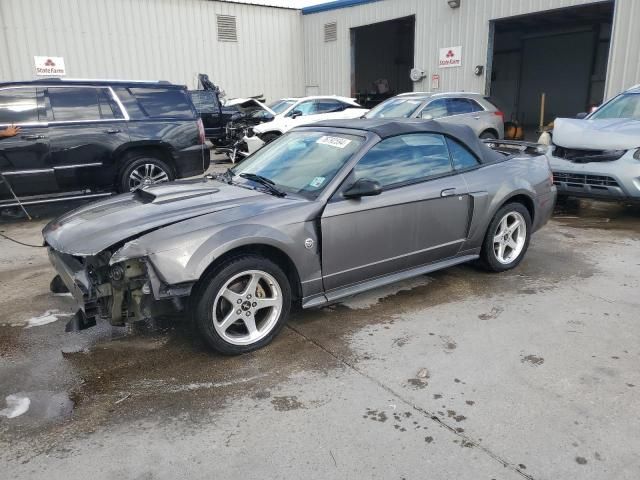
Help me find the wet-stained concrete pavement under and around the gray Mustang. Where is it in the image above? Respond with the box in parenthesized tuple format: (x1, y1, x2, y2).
(0, 197, 640, 479)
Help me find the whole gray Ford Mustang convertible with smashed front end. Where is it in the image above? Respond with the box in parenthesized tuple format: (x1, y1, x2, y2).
(43, 119, 556, 354)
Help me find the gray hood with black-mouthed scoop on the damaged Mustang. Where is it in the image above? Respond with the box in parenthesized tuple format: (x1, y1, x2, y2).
(42, 178, 287, 256)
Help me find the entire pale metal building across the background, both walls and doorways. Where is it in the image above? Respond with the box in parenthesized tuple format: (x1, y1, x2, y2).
(0, 0, 640, 124)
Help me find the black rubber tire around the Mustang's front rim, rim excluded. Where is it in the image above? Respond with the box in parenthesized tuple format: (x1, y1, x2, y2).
(192, 255, 291, 355)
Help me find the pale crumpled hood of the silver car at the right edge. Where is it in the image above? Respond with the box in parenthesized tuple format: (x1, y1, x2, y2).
(553, 118, 640, 150)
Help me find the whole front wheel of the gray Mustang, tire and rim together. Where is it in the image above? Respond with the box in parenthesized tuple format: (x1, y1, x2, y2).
(192, 255, 291, 355)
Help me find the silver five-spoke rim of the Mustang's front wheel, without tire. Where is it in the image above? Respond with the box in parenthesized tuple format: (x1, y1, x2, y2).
(213, 270, 283, 345)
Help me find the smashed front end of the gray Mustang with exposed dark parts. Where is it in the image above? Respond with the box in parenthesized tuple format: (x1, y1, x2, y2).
(48, 247, 191, 329)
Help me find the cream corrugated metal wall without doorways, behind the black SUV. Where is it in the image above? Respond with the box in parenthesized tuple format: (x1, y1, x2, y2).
(0, 0, 304, 99)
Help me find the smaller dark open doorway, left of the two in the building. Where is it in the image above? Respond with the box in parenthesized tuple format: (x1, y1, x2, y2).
(351, 15, 416, 109)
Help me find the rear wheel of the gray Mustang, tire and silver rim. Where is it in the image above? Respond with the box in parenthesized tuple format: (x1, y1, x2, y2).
(480, 203, 531, 272)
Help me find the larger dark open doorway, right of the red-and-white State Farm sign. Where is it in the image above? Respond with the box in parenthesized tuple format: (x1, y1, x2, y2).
(490, 1, 614, 132)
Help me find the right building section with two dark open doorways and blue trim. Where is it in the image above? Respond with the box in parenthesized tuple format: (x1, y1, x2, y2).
(303, 0, 640, 125)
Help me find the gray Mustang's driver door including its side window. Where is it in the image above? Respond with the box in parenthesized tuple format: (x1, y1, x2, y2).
(321, 133, 470, 294)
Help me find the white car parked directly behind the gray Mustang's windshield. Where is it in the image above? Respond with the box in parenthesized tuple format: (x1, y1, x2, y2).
(253, 95, 368, 143)
